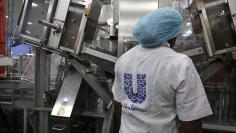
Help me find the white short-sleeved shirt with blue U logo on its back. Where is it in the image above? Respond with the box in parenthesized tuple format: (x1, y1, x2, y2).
(112, 45, 212, 133)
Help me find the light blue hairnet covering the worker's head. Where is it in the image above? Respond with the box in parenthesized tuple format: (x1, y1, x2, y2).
(133, 7, 183, 48)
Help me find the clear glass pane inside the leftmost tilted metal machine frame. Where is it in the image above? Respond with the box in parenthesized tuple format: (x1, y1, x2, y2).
(22, 0, 50, 39)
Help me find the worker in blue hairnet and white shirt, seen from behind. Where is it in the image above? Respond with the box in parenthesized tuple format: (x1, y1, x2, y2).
(112, 8, 212, 133)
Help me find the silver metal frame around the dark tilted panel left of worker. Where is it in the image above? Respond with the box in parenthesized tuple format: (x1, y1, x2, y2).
(49, 0, 101, 54)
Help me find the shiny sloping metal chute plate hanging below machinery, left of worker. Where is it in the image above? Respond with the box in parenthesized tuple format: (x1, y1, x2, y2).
(51, 68, 82, 117)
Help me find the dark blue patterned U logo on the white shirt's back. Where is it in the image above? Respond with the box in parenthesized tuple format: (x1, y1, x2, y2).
(124, 73, 146, 104)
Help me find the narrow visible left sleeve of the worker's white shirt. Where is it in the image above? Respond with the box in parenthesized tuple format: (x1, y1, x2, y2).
(112, 61, 122, 102)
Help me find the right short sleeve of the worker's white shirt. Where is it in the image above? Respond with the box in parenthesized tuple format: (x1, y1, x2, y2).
(176, 57, 212, 121)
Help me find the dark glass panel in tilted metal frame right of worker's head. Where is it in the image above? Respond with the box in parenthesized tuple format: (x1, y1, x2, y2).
(206, 3, 236, 51)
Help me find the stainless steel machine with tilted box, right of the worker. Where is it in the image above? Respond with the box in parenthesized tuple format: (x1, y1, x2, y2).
(174, 0, 236, 132)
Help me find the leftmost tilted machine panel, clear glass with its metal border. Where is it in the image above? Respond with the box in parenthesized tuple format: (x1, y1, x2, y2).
(19, 0, 50, 43)
